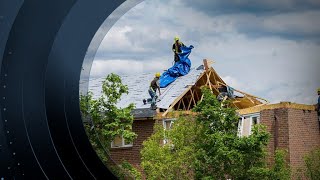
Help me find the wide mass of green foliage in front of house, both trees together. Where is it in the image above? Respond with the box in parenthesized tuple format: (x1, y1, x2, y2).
(141, 89, 288, 179)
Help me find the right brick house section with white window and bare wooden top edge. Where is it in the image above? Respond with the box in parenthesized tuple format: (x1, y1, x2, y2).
(238, 102, 320, 171)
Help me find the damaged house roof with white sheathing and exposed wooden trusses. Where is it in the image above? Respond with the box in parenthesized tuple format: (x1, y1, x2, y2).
(89, 60, 268, 116)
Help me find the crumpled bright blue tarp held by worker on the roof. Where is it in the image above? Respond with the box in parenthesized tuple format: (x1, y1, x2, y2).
(160, 45, 193, 88)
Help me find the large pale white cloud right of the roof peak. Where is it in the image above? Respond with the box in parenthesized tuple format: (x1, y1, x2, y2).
(200, 35, 320, 104)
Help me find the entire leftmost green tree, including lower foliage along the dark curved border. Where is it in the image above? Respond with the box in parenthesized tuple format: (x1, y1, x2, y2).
(80, 73, 139, 179)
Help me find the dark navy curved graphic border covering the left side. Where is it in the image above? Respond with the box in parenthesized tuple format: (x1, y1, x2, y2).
(0, 0, 142, 179)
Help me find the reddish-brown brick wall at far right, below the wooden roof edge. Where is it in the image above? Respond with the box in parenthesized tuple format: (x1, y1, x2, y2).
(260, 108, 320, 170)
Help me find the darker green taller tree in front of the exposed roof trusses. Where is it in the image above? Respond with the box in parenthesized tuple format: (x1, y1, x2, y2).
(194, 89, 270, 179)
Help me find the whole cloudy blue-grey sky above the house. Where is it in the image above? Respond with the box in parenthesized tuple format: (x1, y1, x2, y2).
(91, 0, 320, 104)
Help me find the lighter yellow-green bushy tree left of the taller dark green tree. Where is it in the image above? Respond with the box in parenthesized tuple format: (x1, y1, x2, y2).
(141, 117, 197, 179)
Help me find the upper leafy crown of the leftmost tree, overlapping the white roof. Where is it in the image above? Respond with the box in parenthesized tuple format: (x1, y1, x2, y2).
(80, 73, 137, 147)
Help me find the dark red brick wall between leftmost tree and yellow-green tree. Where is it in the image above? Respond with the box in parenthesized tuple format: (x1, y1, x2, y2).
(110, 120, 154, 169)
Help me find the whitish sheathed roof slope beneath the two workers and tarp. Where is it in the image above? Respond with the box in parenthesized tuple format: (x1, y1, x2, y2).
(89, 65, 204, 109)
